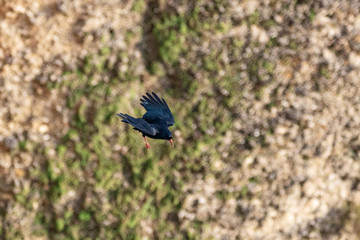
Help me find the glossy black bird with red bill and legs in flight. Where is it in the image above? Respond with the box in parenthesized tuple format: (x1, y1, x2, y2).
(117, 92, 175, 149)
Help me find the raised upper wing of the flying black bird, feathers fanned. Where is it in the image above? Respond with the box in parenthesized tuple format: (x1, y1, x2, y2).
(140, 92, 174, 126)
